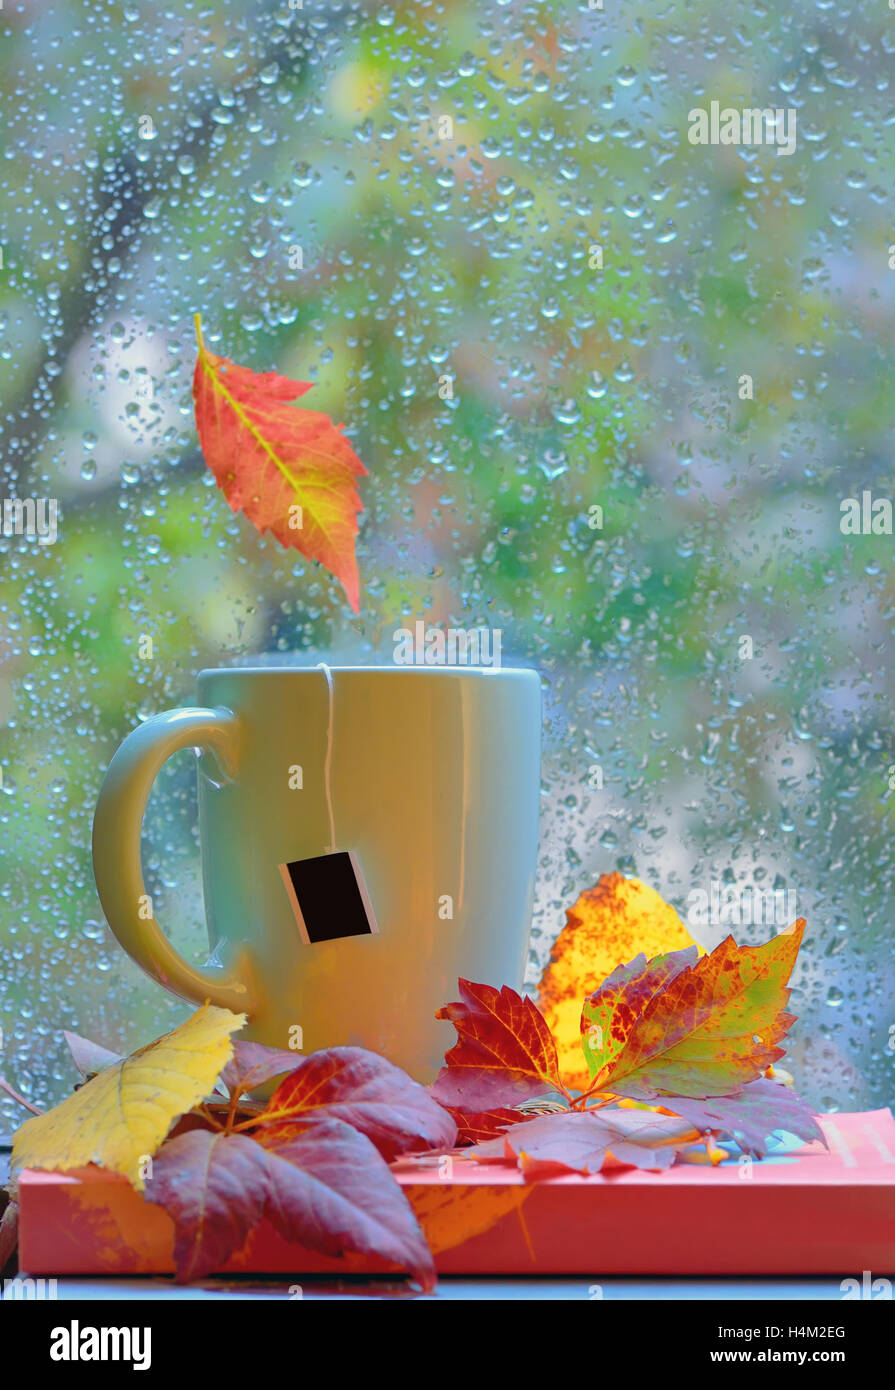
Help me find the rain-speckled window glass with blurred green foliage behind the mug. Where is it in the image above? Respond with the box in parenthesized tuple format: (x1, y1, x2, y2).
(0, 0, 895, 1112)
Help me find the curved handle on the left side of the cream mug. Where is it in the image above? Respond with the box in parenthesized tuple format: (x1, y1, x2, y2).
(93, 706, 257, 1013)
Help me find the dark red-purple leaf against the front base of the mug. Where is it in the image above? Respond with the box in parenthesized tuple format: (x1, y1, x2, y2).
(256, 1047, 457, 1159)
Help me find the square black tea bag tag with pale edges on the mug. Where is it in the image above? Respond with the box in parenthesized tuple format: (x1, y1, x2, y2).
(279, 849, 379, 945)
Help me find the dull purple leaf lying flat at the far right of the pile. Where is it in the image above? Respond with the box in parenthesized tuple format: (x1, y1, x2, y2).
(655, 1077, 827, 1158)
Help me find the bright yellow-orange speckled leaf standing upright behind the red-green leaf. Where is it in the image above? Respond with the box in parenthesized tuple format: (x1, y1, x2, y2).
(538, 873, 698, 1090)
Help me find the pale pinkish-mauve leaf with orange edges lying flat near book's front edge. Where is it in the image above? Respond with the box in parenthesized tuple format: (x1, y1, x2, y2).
(470, 1106, 700, 1179)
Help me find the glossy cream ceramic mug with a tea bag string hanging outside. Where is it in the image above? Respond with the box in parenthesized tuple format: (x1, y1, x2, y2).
(93, 666, 541, 1080)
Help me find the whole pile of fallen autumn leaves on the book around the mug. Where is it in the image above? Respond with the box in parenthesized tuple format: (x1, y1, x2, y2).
(0, 874, 823, 1289)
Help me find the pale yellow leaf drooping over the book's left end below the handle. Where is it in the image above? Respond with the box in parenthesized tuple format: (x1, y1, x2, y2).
(13, 1004, 246, 1190)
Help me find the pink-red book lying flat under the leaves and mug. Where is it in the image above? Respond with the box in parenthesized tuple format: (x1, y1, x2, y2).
(19, 1109, 895, 1277)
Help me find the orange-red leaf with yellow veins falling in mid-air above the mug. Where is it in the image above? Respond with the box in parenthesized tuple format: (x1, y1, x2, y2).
(193, 316, 367, 613)
